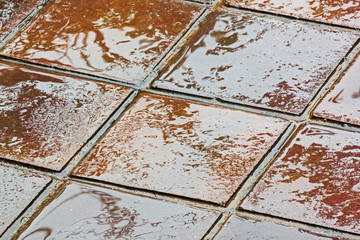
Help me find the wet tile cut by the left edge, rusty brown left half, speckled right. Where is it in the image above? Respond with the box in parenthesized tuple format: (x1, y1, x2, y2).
(0, 63, 131, 170)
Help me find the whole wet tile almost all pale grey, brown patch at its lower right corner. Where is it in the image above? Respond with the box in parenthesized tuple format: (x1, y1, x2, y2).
(154, 11, 358, 114)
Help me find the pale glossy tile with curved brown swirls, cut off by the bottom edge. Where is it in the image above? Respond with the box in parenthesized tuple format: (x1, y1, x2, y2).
(19, 182, 219, 240)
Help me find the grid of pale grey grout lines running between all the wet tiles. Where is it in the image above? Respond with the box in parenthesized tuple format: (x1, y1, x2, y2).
(0, 0, 360, 239)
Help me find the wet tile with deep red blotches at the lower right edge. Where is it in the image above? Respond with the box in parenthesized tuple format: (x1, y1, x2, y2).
(242, 125, 360, 233)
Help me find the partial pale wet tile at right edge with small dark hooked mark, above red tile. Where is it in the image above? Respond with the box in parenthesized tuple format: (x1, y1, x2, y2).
(314, 52, 360, 125)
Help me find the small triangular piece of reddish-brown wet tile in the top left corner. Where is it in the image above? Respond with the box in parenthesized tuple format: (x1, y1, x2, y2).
(0, 0, 41, 40)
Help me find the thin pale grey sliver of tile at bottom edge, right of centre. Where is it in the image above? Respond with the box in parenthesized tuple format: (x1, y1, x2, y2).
(214, 216, 345, 240)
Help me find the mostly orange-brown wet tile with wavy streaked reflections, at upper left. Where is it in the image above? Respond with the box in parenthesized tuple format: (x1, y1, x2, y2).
(2, 0, 204, 84)
